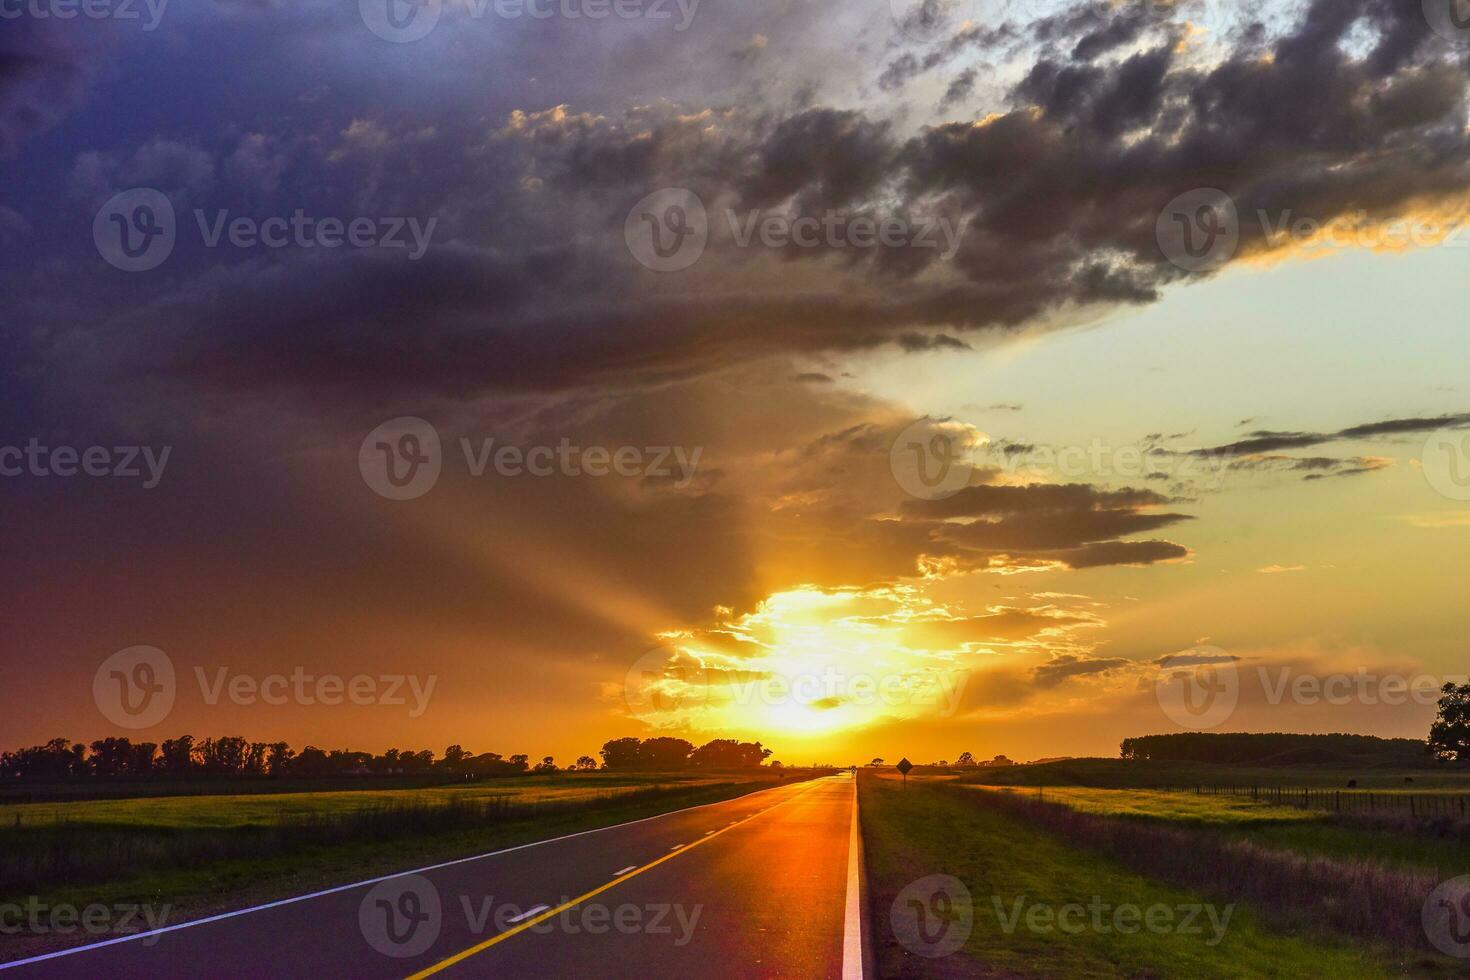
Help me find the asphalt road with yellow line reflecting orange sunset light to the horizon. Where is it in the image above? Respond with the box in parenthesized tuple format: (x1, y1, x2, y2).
(0, 774, 863, 980)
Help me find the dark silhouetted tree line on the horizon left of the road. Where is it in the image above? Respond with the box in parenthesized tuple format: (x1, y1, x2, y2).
(0, 735, 779, 782)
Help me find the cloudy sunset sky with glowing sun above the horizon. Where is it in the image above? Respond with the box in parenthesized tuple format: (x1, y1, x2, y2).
(0, 0, 1470, 764)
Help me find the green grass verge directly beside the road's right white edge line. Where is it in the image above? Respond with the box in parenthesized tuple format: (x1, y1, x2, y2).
(858, 773, 1399, 979)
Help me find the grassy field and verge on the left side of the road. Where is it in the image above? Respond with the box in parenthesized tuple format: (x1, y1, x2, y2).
(0, 768, 811, 961)
